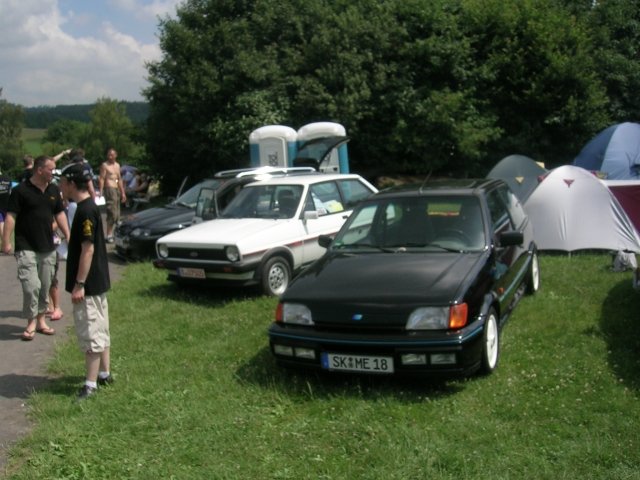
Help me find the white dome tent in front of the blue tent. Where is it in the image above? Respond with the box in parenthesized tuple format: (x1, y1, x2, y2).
(524, 165, 640, 253)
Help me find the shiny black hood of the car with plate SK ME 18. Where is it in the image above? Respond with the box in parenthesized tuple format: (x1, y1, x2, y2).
(283, 252, 487, 306)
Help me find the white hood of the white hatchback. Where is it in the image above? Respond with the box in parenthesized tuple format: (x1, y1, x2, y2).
(158, 218, 292, 251)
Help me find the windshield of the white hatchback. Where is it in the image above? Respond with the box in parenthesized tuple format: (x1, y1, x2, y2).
(220, 185, 303, 218)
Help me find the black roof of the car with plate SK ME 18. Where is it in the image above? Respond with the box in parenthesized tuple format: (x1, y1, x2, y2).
(376, 178, 506, 198)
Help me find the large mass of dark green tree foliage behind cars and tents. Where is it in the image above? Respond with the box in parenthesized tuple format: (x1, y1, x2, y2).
(145, 0, 640, 189)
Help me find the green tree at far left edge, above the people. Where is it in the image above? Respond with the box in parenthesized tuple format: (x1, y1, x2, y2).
(0, 88, 24, 177)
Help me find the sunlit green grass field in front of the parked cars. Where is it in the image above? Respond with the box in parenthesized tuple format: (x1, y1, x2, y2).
(5, 255, 640, 480)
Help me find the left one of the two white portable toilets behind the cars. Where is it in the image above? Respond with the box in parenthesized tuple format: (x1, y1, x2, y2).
(249, 125, 298, 168)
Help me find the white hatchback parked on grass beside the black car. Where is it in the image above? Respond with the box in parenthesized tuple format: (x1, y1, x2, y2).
(154, 173, 377, 295)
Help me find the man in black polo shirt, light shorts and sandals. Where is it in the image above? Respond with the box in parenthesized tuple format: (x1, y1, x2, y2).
(2, 156, 69, 340)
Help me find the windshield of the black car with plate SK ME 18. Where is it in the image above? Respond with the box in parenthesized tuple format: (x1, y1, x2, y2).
(332, 195, 486, 252)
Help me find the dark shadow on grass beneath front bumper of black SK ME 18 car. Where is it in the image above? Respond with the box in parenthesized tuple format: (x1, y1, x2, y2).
(236, 347, 465, 403)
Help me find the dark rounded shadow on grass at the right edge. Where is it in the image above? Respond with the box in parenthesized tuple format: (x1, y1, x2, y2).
(600, 279, 640, 391)
